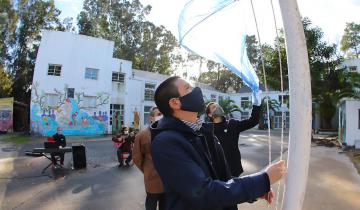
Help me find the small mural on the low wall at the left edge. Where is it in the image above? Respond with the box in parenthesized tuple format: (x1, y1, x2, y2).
(0, 98, 14, 132)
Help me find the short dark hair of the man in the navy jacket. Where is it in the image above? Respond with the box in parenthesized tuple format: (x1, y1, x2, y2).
(154, 76, 180, 117)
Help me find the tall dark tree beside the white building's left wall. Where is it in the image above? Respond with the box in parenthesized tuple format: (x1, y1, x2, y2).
(9, 0, 61, 103)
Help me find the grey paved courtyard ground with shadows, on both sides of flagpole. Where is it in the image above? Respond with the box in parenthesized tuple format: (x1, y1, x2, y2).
(0, 130, 360, 210)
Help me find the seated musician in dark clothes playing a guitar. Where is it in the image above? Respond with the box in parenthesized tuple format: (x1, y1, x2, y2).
(112, 126, 135, 167)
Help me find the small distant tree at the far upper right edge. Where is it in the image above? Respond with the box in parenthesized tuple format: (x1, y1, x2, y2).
(341, 22, 360, 58)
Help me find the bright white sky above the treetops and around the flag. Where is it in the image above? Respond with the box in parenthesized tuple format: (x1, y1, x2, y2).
(55, 0, 360, 77)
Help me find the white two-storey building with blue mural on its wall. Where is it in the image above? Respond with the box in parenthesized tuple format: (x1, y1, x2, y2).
(30, 30, 288, 136)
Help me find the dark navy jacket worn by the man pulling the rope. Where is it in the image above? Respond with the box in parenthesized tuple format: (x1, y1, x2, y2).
(151, 117, 270, 210)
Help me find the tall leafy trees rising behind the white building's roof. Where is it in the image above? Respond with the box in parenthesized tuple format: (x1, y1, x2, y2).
(78, 0, 179, 74)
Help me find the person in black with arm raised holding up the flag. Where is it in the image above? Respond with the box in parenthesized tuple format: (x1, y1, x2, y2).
(205, 91, 261, 176)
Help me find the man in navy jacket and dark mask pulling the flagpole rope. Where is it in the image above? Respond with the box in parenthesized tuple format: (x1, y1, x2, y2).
(151, 76, 285, 210)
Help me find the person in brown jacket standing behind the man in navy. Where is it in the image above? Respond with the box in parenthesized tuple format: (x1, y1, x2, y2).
(133, 107, 165, 210)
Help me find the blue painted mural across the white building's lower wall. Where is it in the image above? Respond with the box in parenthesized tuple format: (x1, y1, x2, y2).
(30, 84, 110, 136)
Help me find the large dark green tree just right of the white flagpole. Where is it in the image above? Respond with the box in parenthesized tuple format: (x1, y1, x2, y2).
(303, 18, 359, 129)
